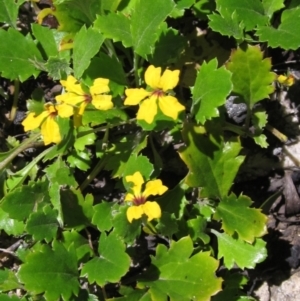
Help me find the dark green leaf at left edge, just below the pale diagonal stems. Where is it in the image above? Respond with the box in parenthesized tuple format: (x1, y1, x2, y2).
(1, 182, 49, 221)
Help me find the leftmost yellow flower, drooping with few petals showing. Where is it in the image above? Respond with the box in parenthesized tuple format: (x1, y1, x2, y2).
(22, 103, 61, 145)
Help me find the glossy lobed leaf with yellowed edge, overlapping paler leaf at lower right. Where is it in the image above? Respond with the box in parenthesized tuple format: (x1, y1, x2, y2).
(214, 193, 267, 243)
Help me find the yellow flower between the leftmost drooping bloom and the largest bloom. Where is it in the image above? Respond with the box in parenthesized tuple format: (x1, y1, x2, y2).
(55, 75, 113, 125)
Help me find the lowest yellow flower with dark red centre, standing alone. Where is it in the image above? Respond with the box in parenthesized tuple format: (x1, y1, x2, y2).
(125, 171, 168, 223)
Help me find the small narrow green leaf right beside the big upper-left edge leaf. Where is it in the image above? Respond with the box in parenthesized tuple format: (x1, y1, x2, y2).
(31, 24, 58, 58)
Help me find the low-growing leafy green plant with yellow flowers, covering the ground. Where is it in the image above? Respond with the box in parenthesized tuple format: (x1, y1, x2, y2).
(0, 0, 300, 301)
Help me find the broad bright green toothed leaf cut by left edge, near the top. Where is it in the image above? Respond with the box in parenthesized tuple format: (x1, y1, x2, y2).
(0, 28, 42, 82)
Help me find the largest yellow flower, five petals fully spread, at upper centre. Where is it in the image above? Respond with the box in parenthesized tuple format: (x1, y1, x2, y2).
(124, 65, 185, 123)
